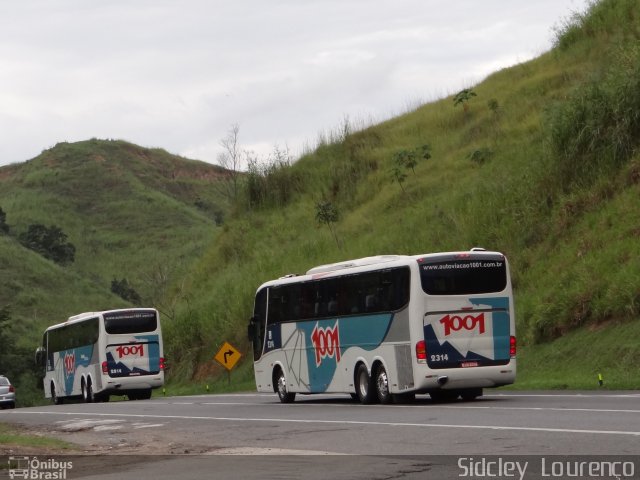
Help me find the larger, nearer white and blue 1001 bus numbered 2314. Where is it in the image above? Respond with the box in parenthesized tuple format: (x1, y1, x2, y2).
(248, 249, 516, 403)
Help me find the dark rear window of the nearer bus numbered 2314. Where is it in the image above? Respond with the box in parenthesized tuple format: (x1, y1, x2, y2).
(420, 257, 507, 295)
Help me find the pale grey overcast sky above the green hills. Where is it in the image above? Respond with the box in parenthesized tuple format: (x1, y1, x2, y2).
(0, 0, 587, 165)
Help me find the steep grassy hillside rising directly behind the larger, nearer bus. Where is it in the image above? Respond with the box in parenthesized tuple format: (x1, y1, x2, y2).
(168, 0, 640, 388)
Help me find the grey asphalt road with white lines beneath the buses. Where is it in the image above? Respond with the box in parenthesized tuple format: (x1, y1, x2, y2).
(0, 391, 640, 480)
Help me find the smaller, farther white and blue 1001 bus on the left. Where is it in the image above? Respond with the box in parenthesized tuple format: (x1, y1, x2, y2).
(36, 308, 164, 405)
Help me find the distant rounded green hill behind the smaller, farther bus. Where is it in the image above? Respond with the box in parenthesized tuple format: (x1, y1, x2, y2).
(0, 140, 228, 349)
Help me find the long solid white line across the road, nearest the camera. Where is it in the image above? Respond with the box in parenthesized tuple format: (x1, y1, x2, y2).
(29, 411, 640, 436)
